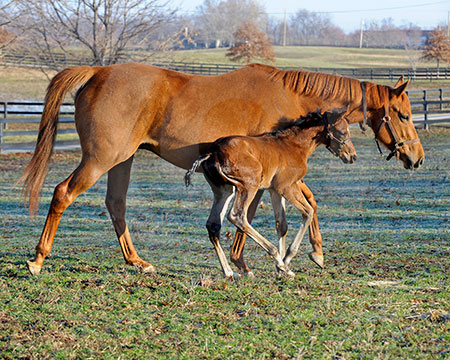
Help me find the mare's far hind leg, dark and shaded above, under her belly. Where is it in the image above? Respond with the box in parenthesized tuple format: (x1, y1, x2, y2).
(105, 155, 155, 273)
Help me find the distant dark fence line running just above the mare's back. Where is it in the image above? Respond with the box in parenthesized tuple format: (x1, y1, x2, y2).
(0, 53, 450, 81)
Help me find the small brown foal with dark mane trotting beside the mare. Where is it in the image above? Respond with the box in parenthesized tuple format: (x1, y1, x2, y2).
(185, 111, 356, 278)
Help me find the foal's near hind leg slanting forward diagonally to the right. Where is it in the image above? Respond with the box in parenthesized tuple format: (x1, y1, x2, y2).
(228, 188, 294, 276)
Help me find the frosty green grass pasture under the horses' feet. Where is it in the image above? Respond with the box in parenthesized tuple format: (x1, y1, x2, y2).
(0, 128, 450, 359)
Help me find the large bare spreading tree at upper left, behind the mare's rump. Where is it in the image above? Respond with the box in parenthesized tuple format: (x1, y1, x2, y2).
(17, 0, 174, 69)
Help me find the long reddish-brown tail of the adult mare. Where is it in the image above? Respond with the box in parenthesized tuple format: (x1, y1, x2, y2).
(16, 66, 100, 215)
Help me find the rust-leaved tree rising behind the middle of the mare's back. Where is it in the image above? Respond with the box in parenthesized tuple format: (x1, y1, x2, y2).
(226, 22, 275, 64)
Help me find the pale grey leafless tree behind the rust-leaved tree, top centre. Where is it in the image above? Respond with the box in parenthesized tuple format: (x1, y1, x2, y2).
(195, 0, 267, 47)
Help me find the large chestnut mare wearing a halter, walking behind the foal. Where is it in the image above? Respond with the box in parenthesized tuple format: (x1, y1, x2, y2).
(20, 63, 424, 275)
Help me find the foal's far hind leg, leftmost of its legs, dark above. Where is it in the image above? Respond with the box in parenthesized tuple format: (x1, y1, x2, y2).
(206, 178, 239, 279)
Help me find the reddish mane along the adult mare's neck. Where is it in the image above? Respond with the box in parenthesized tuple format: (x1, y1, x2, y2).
(249, 64, 392, 109)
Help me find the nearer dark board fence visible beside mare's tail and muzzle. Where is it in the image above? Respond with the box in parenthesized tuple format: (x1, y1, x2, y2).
(0, 88, 450, 153)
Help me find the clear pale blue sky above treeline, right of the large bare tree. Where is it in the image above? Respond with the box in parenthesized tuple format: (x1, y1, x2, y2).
(173, 0, 450, 33)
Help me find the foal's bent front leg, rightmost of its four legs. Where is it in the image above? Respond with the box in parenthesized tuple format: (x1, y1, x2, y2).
(283, 184, 314, 266)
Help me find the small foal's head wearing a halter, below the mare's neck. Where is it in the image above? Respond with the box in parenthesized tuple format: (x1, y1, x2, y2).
(322, 110, 356, 164)
